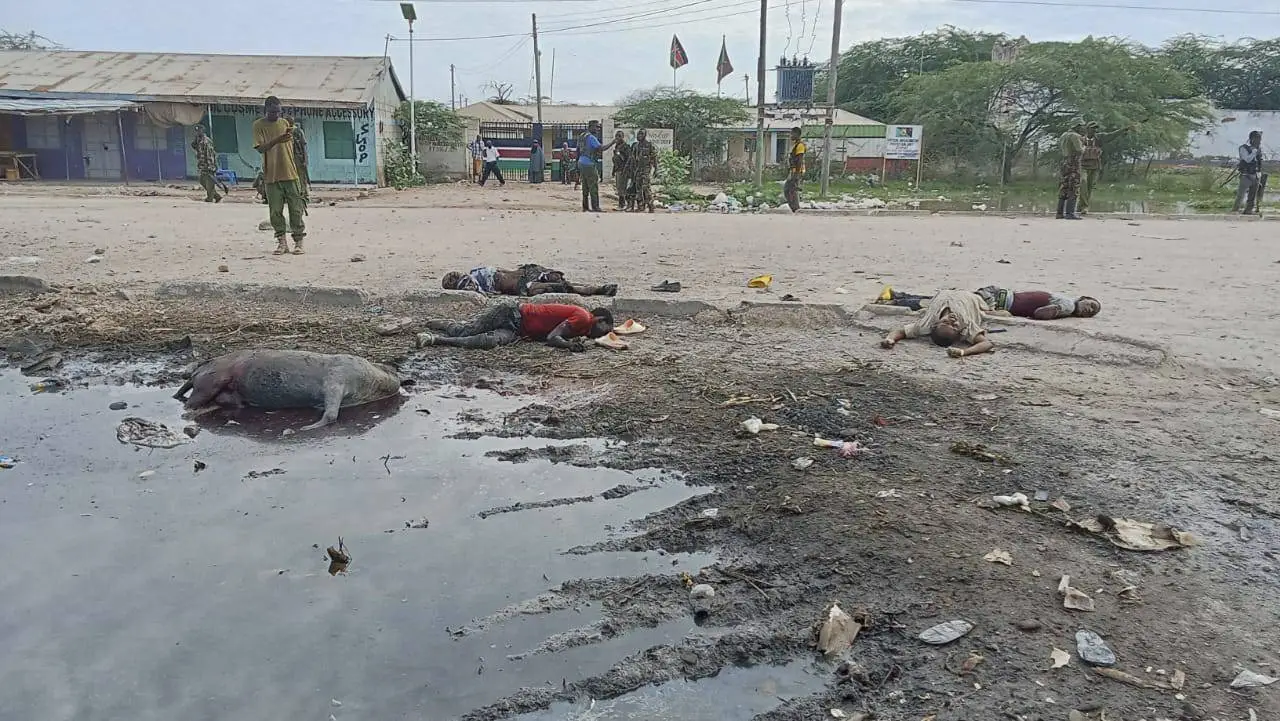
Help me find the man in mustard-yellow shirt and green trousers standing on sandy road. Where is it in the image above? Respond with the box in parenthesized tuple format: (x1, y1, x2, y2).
(253, 95, 307, 255)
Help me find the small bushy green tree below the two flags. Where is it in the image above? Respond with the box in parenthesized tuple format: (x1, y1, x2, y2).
(613, 87, 750, 159)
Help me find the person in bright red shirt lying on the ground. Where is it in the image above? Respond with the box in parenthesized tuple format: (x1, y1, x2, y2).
(417, 304, 613, 352)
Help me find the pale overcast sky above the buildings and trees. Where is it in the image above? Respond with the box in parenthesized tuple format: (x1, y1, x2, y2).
(0, 0, 1280, 112)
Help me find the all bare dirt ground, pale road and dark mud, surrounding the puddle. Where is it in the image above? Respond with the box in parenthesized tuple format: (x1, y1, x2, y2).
(0, 186, 1280, 721)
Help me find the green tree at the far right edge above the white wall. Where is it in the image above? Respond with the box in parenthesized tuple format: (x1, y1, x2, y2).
(1160, 35, 1280, 110)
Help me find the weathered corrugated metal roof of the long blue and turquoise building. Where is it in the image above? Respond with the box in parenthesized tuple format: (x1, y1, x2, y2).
(0, 50, 404, 108)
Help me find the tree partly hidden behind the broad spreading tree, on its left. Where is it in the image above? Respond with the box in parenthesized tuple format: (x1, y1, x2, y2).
(814, 26, 1005, 122)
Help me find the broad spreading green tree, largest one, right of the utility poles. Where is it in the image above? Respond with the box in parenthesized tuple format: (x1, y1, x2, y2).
(893, 38, 1208, 182)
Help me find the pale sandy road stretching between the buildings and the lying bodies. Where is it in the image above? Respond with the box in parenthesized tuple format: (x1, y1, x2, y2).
(0, 183, 1280, 375)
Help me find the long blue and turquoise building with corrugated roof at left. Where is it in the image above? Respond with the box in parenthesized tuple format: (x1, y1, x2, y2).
(0, 51, 406, 184)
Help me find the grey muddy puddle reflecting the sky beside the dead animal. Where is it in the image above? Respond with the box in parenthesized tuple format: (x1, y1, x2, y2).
(0, 370, 716, 721)
